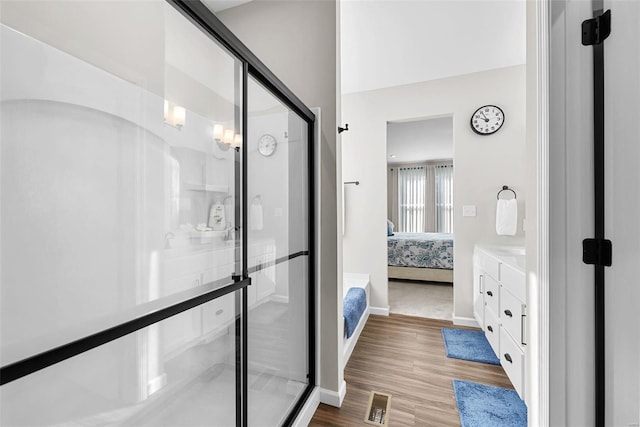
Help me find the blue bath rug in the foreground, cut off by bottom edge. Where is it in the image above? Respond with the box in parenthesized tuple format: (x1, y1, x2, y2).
(453, 380, 527, 427)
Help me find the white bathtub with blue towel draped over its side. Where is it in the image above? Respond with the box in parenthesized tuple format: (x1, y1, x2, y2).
(342, 273, 371, 366)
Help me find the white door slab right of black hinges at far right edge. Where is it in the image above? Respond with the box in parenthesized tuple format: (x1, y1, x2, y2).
(604, 0, 640, 426)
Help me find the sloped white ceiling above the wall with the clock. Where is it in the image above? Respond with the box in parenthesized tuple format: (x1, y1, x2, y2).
(340, 0, 526, 94)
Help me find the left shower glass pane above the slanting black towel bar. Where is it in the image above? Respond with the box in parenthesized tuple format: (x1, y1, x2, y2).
(0, 1, 242, 366)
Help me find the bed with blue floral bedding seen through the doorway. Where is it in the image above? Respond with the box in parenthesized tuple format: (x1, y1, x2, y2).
(387, 233, 453, 283)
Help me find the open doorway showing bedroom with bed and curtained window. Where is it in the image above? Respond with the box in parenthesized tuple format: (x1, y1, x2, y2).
(387, 116, 454, 320)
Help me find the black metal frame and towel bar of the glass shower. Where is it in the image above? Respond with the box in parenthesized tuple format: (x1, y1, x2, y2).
(0, 0, 316, 426)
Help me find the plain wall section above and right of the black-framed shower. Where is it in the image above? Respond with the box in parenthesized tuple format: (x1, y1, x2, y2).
(218, 0, 343, 402)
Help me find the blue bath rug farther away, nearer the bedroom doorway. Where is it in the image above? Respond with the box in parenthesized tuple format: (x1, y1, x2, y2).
(442, 328, 500, 365)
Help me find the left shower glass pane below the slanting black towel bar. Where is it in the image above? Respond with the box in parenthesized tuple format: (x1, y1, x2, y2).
(0, 293, 238, 427)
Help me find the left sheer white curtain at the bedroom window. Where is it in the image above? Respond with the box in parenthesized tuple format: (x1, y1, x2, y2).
(398, 166, 427, 233)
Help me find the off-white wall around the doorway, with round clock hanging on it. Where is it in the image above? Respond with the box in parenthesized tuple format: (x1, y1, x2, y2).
(342, 65, 527, 319)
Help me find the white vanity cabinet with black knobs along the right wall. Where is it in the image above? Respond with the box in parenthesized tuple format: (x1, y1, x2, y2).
(473, 245, 527, 399)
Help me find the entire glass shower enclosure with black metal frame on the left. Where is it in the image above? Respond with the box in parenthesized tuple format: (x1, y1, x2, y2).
(0, 1, 315, 426)
